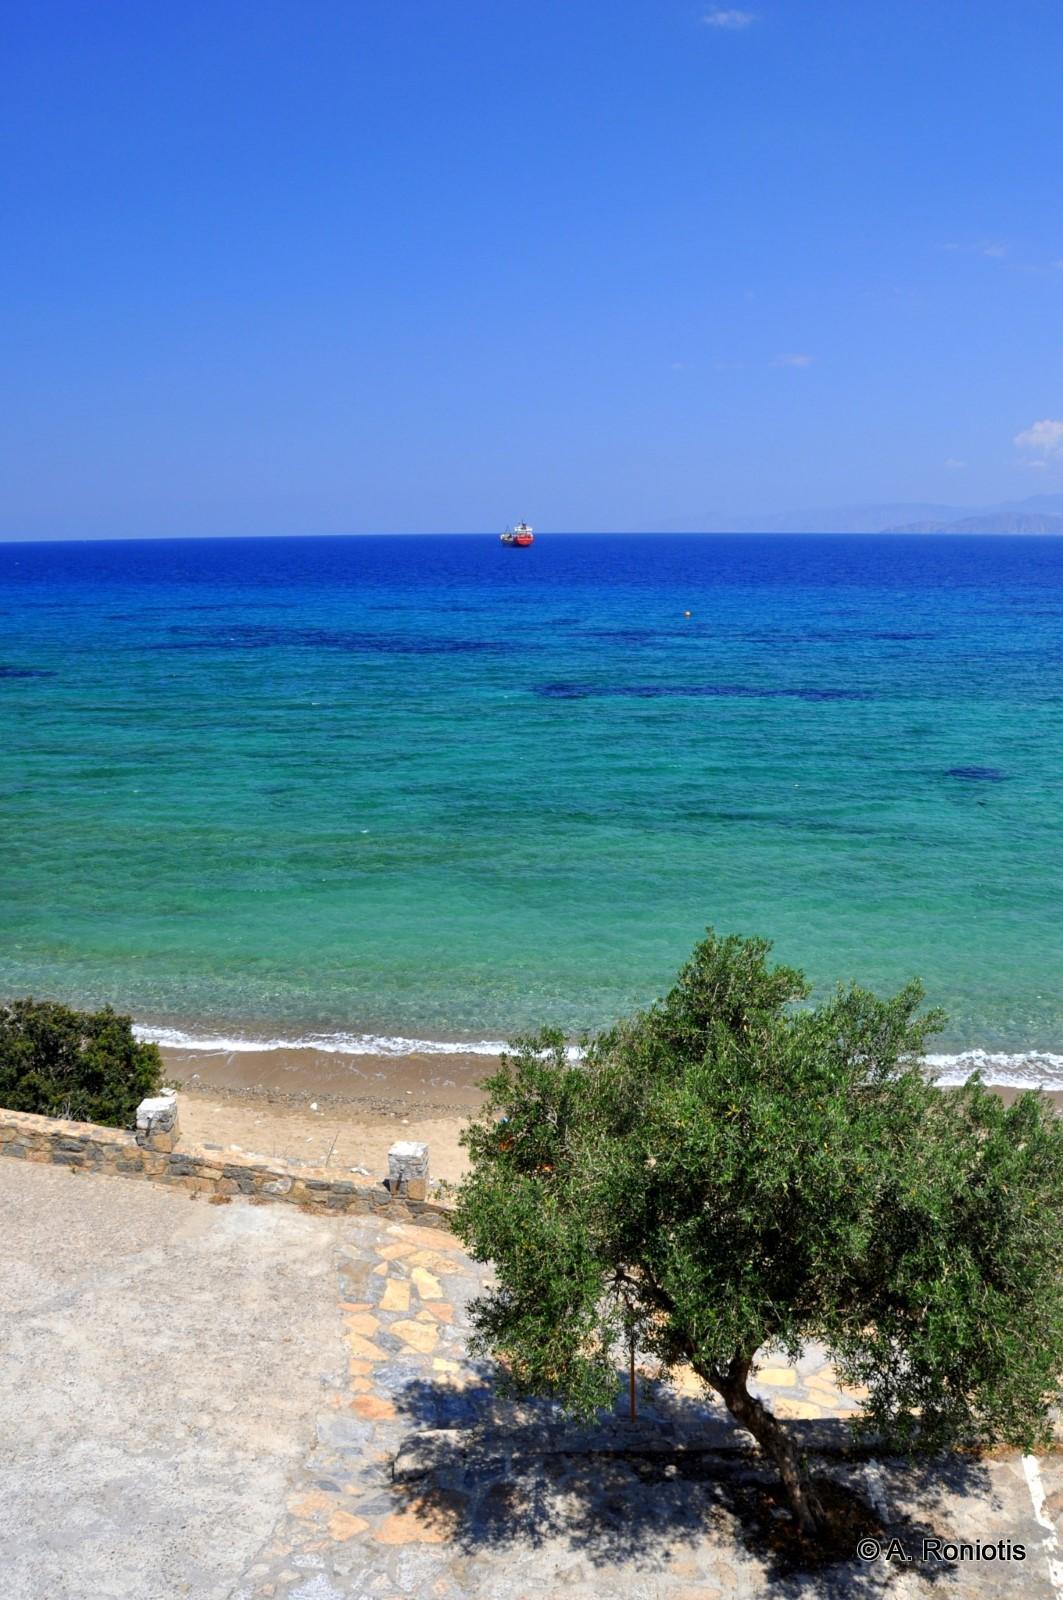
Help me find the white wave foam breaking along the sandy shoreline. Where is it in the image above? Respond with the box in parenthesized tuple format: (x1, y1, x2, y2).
(133, 1022, 1063, 1090)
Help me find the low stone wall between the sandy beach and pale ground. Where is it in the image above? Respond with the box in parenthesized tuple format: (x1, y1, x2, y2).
(0, 1107, 448, 1227)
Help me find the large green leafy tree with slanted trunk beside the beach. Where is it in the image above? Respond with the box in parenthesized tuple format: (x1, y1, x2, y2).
(456, 933, 1063, 1523)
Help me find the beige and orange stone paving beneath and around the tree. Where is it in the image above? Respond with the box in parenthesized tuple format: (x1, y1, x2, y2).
(234, 1219, 1063, 1600)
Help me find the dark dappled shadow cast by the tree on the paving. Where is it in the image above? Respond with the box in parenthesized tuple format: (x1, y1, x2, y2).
(392, 1366, 994, 1600)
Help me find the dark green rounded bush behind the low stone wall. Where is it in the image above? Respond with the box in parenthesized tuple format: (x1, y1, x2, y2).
(0, 1000, 162, 1128)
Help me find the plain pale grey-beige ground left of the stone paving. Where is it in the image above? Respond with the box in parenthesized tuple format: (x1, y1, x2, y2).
(0, 1160, 344, 1600)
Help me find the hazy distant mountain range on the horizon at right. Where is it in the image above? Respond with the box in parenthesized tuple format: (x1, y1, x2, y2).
(661, 494, 1063, 534)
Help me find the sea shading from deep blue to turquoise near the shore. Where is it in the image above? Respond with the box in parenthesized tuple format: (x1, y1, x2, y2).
(0, 533, 1063, 1086)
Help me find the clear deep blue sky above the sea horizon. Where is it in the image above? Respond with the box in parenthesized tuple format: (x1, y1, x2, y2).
(0, 0, 1063, 538)
